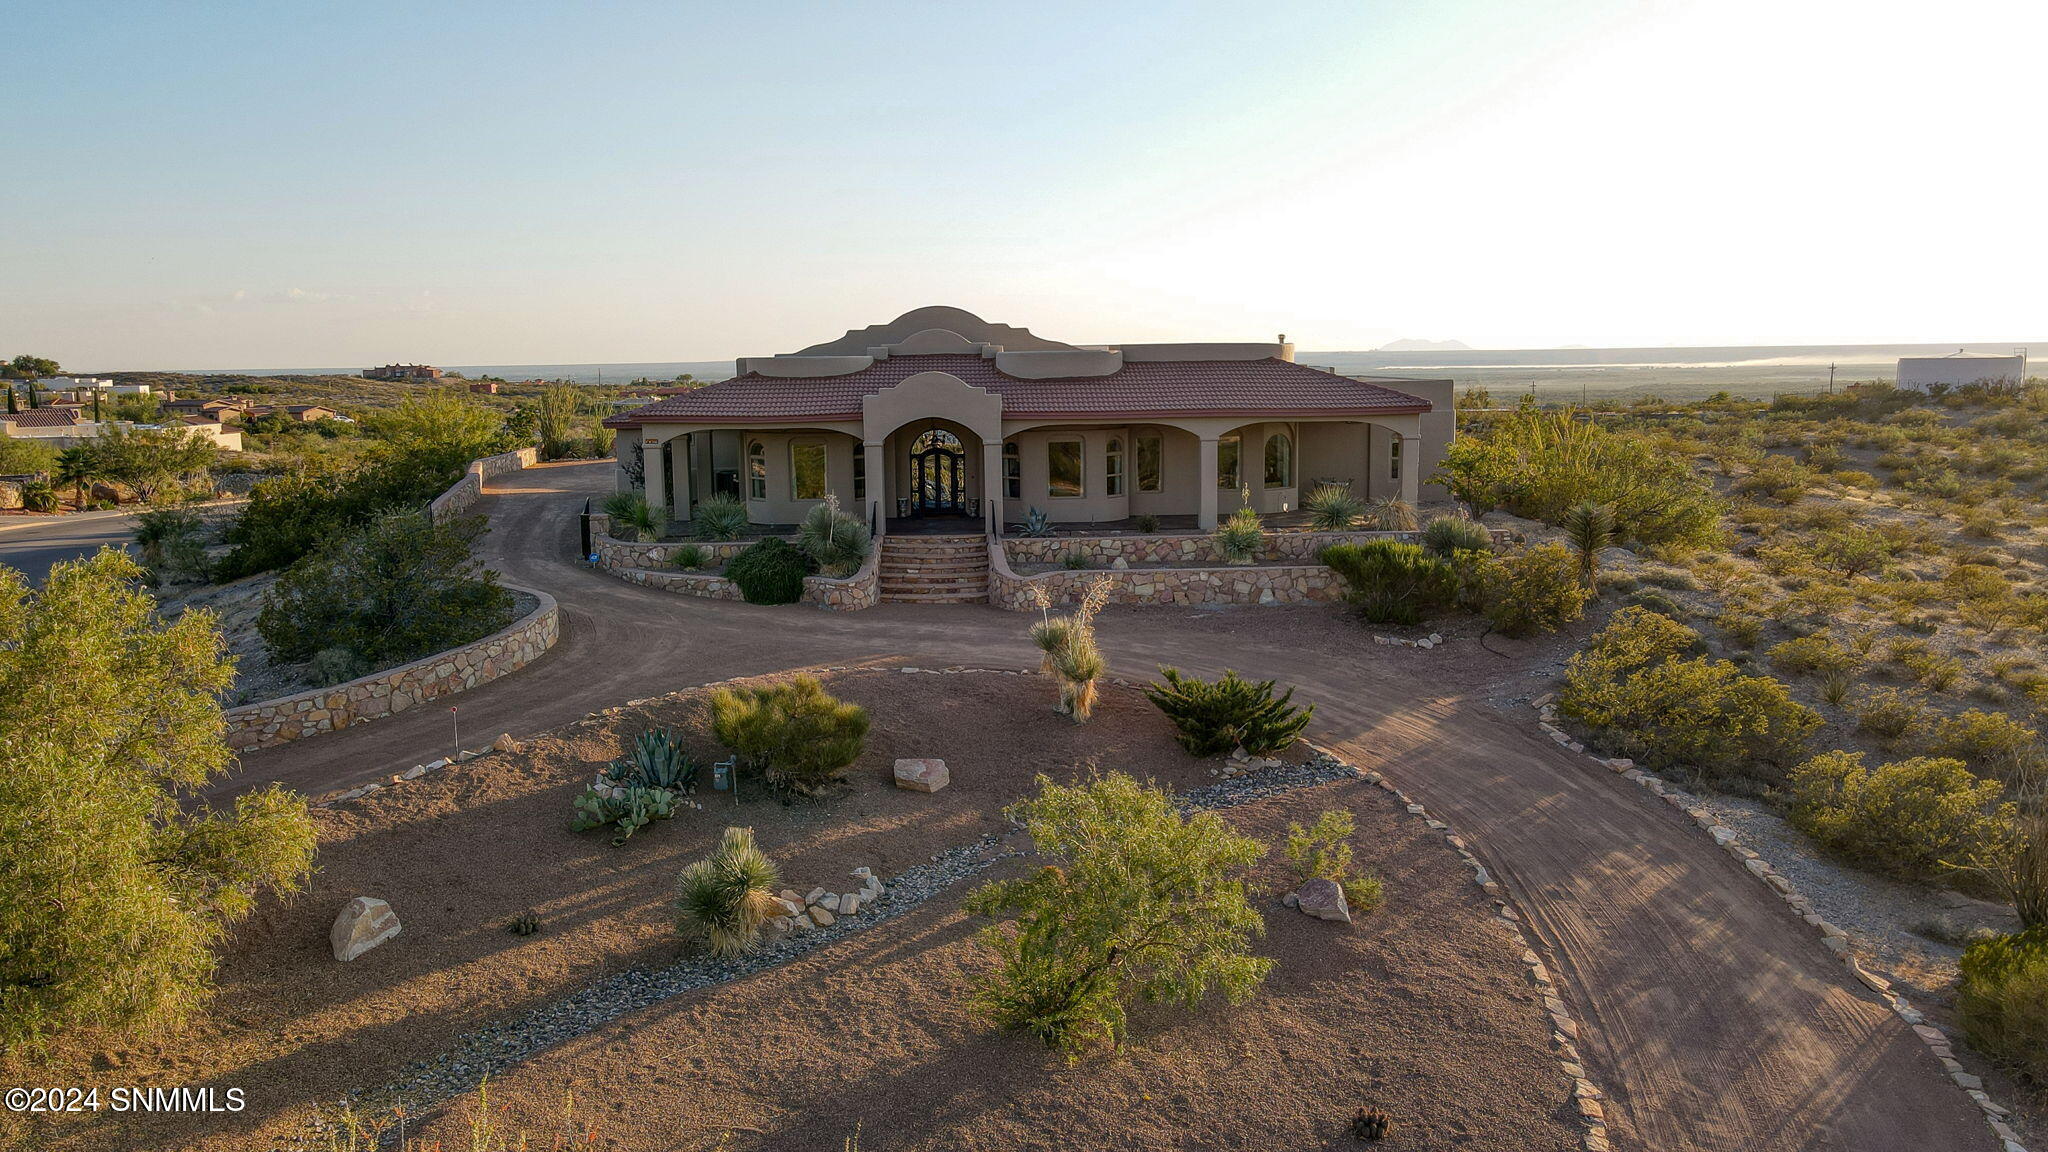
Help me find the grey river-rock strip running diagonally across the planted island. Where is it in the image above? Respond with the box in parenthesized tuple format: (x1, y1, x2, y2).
(303, 752, 1360, 1139)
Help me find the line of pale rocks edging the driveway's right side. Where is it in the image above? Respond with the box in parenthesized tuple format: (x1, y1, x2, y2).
(1530, 693, 2028, 1152)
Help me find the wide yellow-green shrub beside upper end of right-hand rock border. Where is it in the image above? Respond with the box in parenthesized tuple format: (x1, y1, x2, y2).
(1559, 607, 1821, 777)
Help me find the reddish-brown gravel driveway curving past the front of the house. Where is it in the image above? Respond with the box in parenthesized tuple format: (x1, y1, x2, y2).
(223, 463, 1995, 1152)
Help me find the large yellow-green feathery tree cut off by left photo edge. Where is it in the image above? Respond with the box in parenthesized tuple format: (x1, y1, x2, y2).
(0, 549, 315, 1045)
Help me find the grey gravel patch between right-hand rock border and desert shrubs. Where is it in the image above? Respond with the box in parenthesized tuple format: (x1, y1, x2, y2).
(1694, 778, 2019, 998)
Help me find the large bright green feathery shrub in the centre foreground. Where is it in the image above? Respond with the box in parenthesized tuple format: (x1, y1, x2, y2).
(967, 773, 1274, 1054)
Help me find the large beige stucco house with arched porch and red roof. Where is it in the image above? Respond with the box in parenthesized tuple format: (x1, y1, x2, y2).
(604, 307, 1456, 529)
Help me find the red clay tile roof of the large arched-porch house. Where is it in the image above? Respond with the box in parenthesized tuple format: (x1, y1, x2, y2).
(604, 355, 1430, 428)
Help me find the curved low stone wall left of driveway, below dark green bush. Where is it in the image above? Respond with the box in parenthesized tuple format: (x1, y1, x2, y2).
(227, 584, 561, 752)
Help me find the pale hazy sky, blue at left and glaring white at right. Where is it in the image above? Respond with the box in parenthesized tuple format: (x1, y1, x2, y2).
(0, 0, 2048, 371)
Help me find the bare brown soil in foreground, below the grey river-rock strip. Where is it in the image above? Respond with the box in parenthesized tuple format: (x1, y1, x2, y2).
(407, 781, 1577, 1152)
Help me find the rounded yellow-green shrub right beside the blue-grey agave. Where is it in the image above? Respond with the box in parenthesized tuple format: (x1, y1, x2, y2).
(711, 676, 868, 795)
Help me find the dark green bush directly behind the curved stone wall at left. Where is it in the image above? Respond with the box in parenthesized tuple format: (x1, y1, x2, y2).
(256, 510, 512, 668)
